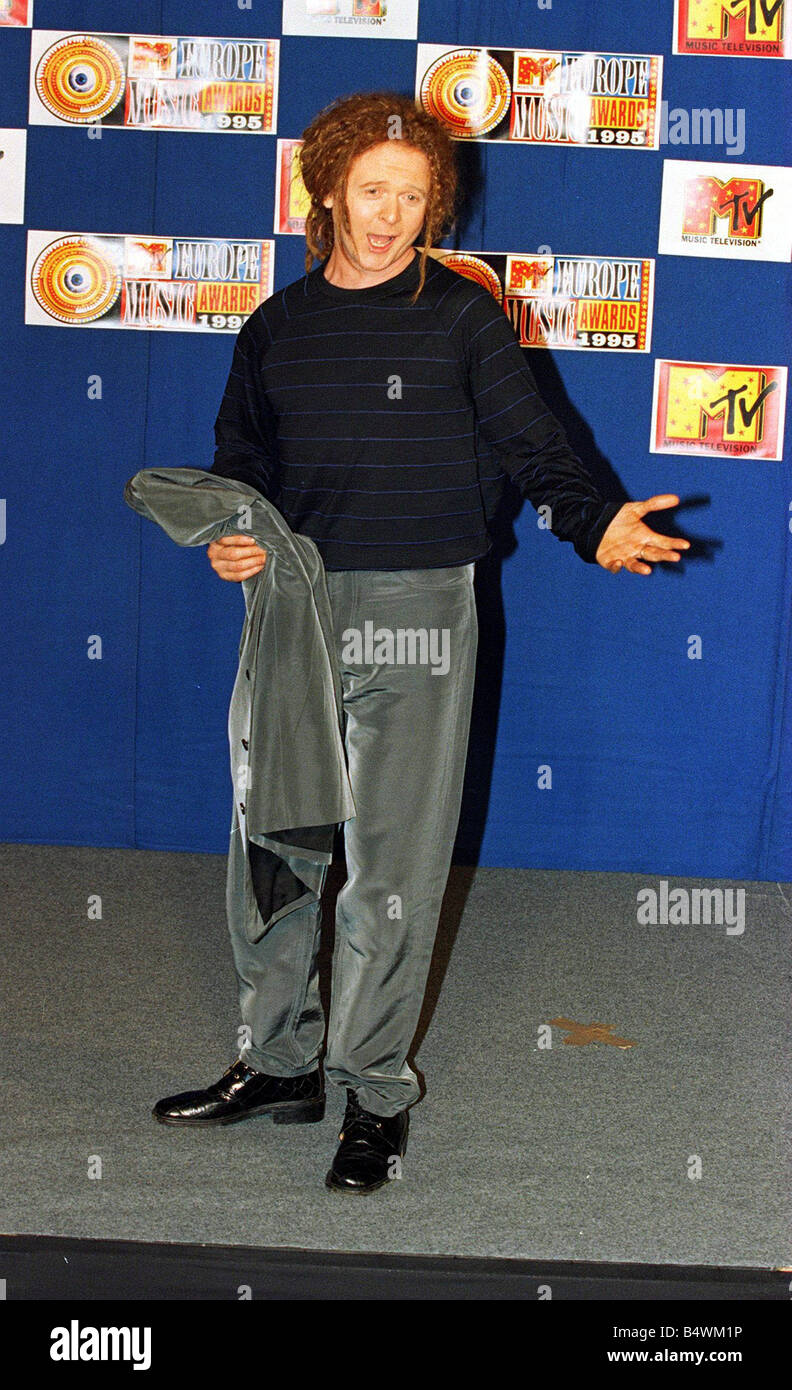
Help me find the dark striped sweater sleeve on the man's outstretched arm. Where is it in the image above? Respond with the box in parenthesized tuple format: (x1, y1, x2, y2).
(454, 293, 621, 564)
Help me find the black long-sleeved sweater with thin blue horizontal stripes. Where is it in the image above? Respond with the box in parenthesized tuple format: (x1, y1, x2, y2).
(211, 256, 618, 570)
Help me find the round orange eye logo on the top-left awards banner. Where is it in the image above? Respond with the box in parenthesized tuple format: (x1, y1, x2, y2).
(36, 33, 125, 124)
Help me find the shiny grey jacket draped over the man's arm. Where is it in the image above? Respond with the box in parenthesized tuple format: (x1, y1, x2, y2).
(124, 468, 356, 941)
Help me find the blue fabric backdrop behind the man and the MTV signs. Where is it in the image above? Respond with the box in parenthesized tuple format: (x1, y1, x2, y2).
(0, 0, 792, 878)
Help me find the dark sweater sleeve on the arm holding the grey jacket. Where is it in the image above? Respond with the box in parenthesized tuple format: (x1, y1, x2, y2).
(208, 311, 279, 506)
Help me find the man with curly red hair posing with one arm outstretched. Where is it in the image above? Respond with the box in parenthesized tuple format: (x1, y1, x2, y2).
(154, 92, 688, 1193)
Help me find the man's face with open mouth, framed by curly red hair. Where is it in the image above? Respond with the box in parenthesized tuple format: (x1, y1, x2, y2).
(324, 140, 431, 284)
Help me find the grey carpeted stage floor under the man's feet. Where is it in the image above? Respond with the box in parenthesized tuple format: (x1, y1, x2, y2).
(0, 845, 792, 1268)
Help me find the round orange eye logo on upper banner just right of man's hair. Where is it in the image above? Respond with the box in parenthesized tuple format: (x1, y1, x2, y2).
(420, 49, 511, 140)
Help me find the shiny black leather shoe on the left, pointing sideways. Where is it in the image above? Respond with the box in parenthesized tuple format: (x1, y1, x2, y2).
(151, 1058, 325, 1125)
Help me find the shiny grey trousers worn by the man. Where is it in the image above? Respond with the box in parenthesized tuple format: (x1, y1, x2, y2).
(226, 563, 478, 1116)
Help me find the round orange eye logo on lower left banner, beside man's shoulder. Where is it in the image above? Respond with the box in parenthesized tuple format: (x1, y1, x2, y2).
(31, 236, 122, 324)
